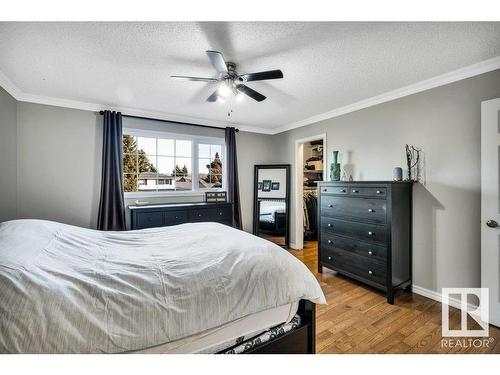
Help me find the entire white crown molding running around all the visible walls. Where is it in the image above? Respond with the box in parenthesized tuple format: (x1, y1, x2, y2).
(0, 56, 500, 135)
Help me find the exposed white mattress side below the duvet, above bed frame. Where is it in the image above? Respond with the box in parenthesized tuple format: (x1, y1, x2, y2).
(131, 302, 299, 354)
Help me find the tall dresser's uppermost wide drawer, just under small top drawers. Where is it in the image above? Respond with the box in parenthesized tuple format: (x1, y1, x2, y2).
(321, 196, 387, 224)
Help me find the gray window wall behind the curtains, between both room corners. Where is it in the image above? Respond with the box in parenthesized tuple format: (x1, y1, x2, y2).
(10, 101, 274, 231)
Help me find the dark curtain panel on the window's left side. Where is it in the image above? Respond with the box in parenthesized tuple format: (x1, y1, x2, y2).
(97, 111, 125, 230)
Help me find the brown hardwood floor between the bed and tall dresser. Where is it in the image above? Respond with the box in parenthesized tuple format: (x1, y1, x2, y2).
(289, 242, 500, 354)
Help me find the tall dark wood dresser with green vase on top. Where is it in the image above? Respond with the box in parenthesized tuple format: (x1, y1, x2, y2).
(318, 181, 412, 304)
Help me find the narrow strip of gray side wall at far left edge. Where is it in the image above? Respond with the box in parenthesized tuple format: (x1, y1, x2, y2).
(0, 87, 17, 222)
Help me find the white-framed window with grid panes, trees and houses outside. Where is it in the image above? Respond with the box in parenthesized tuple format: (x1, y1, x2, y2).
(123, 130, 224, 195)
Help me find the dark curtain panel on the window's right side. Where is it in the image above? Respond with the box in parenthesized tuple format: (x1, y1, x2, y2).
(226, 127, 241, 229)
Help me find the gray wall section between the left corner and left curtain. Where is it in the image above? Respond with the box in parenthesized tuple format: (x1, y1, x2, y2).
(17, 102, 102, 228)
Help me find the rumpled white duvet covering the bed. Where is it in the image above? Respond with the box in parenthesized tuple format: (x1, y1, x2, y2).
(0, 220, 325, 353)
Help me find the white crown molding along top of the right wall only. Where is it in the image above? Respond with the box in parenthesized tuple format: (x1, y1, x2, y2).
(273, 56, 500, 134)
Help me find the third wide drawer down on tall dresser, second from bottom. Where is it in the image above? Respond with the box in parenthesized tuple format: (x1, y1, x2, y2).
(321, 232, 387, 263)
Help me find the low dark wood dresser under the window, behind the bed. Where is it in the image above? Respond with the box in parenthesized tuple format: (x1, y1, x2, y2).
(128, 203, 233, 230)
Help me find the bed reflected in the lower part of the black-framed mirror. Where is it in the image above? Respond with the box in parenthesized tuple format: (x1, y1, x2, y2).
(259, 198, 286, 236)
